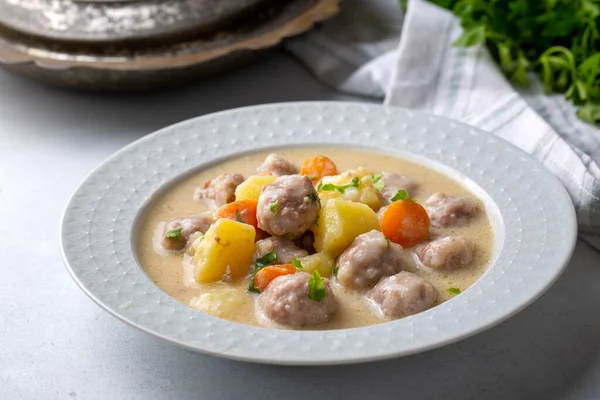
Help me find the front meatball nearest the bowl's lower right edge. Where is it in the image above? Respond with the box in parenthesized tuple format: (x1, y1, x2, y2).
(370, 271, 436, 318)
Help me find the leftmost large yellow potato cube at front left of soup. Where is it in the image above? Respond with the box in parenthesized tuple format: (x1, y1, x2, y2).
(193, 218, 256, 283)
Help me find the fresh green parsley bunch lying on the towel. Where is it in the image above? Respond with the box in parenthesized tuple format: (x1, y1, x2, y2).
(412, 0, 600, 125)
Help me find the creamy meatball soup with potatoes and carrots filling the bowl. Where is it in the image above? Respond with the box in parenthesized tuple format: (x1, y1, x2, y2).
(137, 147, 494, 329)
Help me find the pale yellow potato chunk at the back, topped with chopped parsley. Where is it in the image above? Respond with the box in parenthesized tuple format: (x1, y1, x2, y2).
(319, 167, 381, 211)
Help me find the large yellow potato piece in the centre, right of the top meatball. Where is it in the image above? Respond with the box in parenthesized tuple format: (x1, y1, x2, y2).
(311, 199, 381, 258)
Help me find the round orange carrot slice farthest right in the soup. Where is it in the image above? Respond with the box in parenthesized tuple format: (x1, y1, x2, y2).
(381, 200, 429, 247)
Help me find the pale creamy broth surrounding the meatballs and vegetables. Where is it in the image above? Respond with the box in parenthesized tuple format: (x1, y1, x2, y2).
(137, 147, 494, 329)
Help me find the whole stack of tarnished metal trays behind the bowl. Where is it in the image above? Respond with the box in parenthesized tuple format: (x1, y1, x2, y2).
(0, 0, 340, 90)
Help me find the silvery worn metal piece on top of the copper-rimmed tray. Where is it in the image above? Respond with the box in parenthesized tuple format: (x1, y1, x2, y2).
(0, 0, 274, 43)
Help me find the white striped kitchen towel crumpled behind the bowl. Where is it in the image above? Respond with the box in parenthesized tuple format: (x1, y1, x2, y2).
(287, 0, 600, 249)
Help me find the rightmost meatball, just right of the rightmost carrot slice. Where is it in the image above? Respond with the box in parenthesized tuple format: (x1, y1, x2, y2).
(423, 193, 479, 228)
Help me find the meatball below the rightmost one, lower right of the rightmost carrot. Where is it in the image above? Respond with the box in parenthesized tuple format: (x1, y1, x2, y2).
(417, 236, 475, 269)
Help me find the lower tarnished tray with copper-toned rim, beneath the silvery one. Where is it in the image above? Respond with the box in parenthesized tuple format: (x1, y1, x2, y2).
(0, 0, 340, 91)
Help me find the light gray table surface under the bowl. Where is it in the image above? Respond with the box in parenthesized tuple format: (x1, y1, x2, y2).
(0, 54, 600, 400)
